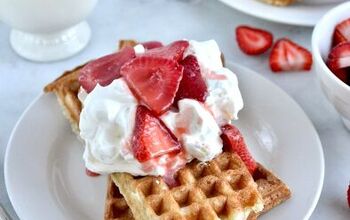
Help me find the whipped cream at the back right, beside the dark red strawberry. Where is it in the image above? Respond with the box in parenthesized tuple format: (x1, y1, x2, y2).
(184, 40, 243, 126)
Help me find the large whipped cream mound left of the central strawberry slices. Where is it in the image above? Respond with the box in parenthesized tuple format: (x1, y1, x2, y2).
(79, 78, 158, 175)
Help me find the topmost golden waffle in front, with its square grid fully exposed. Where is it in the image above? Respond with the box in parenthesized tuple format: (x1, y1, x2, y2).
(112, 152, 263, 220)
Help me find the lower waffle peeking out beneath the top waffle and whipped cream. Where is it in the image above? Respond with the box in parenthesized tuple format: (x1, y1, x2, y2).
(44, 40, 291, 220)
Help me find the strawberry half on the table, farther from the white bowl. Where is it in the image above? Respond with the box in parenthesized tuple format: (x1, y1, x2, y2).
(236, 26, 273, 55)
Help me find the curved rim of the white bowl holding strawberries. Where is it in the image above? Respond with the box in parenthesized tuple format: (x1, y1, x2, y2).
(311, 2, 350, 92)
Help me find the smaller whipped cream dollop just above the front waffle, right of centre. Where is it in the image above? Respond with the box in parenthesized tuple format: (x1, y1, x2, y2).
(161, 99, 222, 162)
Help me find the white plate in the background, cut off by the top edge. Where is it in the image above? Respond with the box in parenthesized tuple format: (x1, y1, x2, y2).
(220, 0, 345, 26)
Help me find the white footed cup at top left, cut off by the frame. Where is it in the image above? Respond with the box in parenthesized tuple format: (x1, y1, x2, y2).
(0, 0, 97, 61)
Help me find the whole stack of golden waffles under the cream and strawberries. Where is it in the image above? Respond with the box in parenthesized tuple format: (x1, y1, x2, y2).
(44, 40, 291, 220)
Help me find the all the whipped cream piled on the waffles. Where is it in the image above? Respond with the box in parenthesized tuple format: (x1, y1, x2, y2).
(78, 40, 243, 175)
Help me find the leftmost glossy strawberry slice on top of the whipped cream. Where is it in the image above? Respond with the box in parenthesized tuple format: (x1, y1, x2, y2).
(79, 47, 135, 93)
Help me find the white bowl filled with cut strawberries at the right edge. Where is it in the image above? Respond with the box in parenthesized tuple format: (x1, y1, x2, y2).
(312, 2, 350, 129)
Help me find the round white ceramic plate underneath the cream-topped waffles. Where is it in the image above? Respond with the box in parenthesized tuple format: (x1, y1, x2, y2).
(5, 64, 324, 220)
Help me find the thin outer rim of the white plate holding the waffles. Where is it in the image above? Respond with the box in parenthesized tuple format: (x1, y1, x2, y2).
(4, 61, 325, 219)
